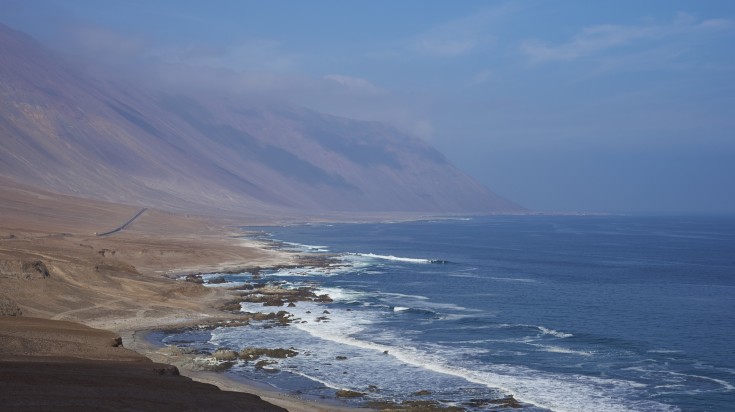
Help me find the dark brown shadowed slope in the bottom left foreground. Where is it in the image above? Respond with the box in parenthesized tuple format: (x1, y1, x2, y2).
(0, 316, 286, 412)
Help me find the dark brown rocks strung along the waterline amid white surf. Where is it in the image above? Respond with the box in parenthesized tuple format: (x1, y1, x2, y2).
(148, 255, 522, 412)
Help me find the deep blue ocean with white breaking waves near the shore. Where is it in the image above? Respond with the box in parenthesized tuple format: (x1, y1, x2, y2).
(164, 216, 735, 411)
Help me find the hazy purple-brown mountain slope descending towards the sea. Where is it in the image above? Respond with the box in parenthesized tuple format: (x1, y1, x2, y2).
(0, 25, 524, 217)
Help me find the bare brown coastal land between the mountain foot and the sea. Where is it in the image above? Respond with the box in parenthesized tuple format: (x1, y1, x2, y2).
(0, 185, 374, 412)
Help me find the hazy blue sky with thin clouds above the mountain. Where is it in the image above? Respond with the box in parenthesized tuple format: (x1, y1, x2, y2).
(0, 0, 735, 213)
